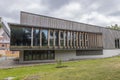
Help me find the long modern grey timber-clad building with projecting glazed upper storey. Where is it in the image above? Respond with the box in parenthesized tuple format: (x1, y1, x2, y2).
(1, 12, 120, 63)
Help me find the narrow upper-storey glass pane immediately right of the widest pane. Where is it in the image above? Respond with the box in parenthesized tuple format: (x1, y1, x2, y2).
(33, 28, 40, 46)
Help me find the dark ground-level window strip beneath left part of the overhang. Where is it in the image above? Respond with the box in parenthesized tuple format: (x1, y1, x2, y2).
(24, 50, 55, 61)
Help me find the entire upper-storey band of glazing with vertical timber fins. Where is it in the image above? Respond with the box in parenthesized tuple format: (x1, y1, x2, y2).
(11, 26, 102, 48)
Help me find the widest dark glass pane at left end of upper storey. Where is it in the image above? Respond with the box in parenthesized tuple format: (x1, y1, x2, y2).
(11, 27, 31, 46)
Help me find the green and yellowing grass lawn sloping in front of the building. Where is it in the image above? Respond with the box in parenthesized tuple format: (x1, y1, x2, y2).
(0, 56, 120, 80)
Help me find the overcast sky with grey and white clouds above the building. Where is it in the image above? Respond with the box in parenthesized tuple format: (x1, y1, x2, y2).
(0, 0, 120, 27)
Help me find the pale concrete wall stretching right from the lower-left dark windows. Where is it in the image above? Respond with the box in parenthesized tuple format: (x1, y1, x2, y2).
(55, 49, 120, 60)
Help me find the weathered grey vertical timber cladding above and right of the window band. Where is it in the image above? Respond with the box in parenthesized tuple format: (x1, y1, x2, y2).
(20, 12, 120, 48)
